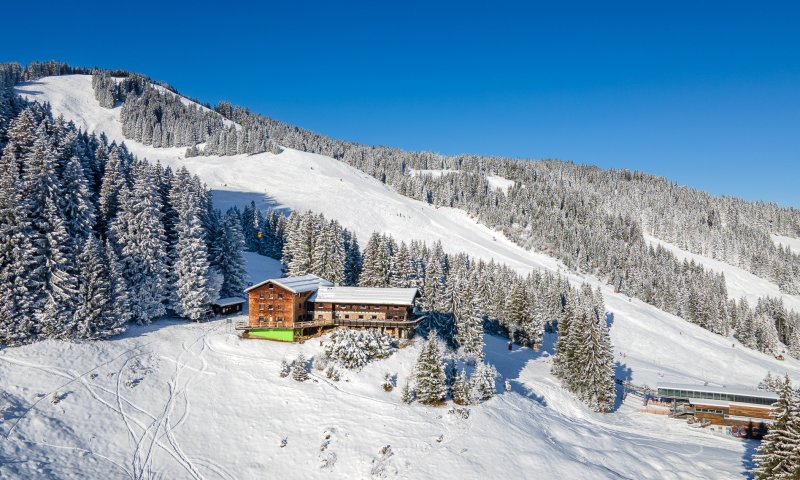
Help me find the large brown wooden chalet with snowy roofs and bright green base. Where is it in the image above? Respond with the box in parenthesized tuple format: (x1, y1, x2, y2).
(236, 275, 420, 342)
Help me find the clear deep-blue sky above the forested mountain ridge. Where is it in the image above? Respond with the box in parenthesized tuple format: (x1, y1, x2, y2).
(6, 0, 800, 207)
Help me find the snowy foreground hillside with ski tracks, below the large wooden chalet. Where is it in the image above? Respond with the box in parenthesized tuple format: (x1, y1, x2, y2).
(0, 255, 768, 479)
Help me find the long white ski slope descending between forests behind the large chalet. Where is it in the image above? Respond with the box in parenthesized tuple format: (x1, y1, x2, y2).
(16, 75, 800, 387)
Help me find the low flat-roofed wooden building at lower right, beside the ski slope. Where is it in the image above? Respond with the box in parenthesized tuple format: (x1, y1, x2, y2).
(658, 383, 778, 438)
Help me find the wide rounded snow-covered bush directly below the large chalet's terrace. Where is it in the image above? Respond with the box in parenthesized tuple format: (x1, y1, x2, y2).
(318, 329, 394, 369)
